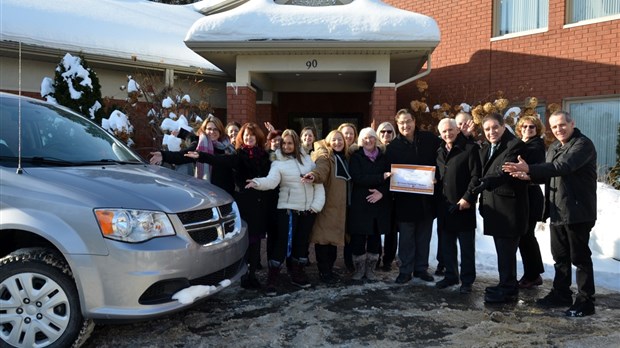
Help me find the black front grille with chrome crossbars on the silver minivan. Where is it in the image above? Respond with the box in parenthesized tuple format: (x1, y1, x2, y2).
(177, 207, 240, 245)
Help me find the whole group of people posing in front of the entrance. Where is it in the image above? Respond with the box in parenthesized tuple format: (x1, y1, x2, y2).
(151, 109, 596, 316)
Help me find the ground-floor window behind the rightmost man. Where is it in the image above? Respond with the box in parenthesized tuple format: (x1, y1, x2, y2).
(564, 95, 620, 176)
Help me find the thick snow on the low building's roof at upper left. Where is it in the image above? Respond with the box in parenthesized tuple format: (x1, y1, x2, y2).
(0, 0, 220, 71)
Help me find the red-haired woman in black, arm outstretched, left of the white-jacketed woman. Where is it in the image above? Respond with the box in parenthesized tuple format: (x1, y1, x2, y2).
(187, 123, 276, 289)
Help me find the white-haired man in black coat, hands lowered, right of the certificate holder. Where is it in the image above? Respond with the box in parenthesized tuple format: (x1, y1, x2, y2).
(435, 118, 481, 294)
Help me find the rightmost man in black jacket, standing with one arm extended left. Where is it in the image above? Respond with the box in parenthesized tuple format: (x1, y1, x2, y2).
(504, 111, 597, 317)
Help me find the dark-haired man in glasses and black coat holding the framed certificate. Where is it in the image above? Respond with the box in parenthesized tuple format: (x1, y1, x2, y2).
(386, 109, 440, 284)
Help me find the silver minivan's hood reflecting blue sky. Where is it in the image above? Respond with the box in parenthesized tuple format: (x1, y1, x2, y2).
(17, 164, 232, 213)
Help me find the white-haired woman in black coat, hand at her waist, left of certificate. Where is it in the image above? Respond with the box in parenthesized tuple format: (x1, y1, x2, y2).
(348, 127, 392, 280)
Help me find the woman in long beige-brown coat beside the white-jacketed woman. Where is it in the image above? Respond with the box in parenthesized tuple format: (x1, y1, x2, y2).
(310, 130, 351, 283)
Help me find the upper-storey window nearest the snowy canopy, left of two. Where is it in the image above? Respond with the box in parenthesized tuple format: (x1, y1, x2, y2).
(493, 0, 548, 37)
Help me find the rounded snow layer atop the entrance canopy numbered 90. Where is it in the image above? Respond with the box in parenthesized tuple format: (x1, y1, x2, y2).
(185, 0, 440, 42)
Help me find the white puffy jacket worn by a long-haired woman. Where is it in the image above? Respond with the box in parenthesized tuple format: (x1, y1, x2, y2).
(252, 150, 325, 213)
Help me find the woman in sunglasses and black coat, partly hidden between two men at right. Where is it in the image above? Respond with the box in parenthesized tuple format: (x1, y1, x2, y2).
(516, 116, 545, 289)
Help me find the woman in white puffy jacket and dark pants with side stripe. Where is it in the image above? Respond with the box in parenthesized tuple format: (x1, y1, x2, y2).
(246, 129, 325, 296)
